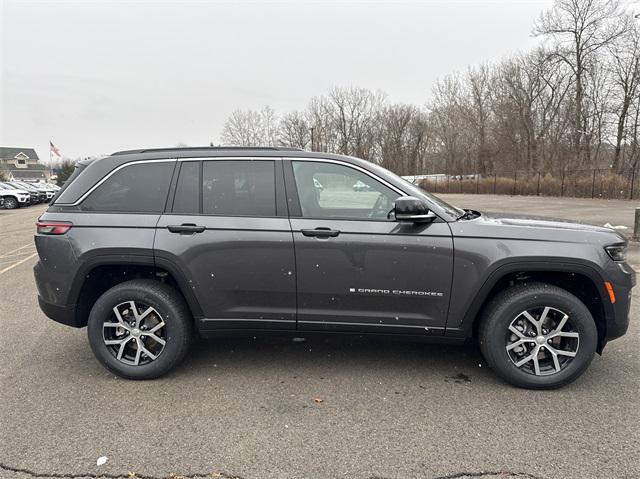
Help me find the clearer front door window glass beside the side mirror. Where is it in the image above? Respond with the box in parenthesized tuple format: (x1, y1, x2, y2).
(293, 161, 400, 220)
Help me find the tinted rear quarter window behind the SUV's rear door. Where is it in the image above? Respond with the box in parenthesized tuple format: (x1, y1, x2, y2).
(81, 161, 175, 213)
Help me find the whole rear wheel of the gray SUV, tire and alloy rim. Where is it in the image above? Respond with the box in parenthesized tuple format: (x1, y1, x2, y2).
(87, 280, 193, 379)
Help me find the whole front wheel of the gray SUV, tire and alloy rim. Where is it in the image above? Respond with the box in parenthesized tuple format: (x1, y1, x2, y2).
(479, 283, 598, 389)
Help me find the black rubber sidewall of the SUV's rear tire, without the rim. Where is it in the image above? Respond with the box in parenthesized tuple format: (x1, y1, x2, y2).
(87, 283, 188, 379)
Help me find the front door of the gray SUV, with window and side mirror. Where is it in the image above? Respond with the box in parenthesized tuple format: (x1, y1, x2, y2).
(285, 160, 453, 335)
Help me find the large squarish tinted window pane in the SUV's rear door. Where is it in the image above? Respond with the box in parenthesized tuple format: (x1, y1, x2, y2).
(202, 160, 276, 216)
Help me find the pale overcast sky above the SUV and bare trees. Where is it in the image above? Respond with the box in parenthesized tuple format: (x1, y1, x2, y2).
(0, 0, 552, 160)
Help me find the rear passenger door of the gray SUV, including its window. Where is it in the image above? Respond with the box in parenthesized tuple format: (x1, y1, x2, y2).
(154, 158, 296, 329)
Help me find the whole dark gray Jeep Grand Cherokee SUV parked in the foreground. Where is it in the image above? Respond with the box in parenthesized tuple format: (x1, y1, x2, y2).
(35, 148, 635, 389)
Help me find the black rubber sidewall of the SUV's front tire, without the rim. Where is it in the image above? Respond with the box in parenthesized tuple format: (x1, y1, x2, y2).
(481, 290, 598, 389)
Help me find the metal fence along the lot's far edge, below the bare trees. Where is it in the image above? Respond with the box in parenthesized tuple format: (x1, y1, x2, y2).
(418, 169, 640, 200)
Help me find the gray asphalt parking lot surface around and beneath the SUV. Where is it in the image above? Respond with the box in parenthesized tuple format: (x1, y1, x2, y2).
(0, 195, 640, 479)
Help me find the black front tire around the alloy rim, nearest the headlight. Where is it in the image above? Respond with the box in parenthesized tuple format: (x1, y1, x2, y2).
(478, 283, 598, 389)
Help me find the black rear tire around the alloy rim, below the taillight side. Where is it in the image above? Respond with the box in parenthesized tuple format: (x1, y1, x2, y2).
(87, 279, 193, 379)
